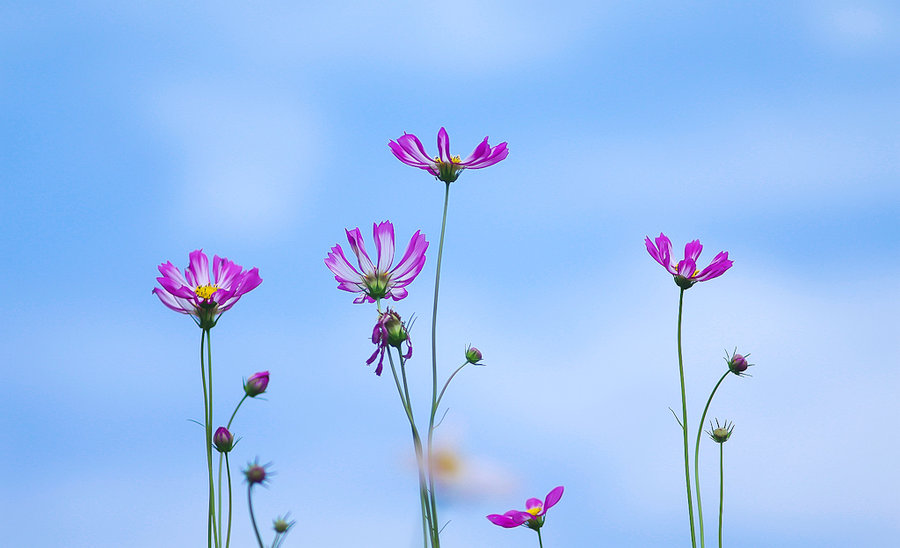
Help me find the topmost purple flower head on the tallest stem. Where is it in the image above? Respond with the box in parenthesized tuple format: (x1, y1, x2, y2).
(388, 128, 509, 183)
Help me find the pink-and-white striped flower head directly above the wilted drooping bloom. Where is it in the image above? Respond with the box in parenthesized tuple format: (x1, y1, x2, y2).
(325, 221, 428, 304)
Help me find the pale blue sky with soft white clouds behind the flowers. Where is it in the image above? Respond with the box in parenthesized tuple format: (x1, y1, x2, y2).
(0, 1, 900, 548)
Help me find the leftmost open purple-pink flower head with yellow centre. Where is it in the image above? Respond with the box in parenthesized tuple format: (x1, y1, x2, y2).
(153, 249, 262, 329)
